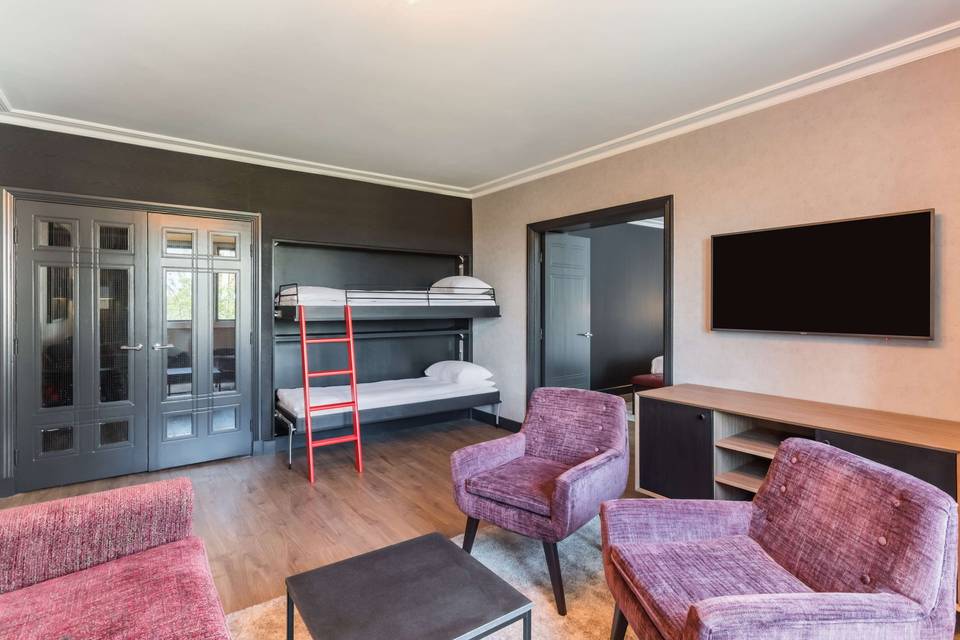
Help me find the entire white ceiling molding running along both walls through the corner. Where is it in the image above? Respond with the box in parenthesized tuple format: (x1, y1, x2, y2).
(0, 21, 960, 198)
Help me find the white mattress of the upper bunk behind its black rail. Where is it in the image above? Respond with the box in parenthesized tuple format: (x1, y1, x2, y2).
(277, 286, 496, 307)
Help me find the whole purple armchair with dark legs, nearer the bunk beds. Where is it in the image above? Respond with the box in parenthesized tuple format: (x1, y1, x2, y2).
(450, 387, 630, 615)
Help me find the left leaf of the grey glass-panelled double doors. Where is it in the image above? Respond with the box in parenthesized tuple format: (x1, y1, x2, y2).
(15, 200, 148, 491)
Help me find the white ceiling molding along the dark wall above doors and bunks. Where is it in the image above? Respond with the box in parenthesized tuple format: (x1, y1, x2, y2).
(0, 105, 470, 198)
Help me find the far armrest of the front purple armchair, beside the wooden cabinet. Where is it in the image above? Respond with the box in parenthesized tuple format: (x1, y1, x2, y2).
(600, 498, 753, 549)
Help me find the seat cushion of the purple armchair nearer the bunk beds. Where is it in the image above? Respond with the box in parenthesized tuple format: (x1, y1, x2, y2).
(466, 456, 570, 518)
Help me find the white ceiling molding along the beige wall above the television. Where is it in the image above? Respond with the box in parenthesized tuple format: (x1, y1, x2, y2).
(469, 21, 960, 198)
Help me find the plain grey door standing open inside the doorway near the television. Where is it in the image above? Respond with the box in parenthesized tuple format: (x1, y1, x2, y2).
(543, 233, 593, 389)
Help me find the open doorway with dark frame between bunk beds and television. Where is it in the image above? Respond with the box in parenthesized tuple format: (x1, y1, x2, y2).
(527, 196, 673, 402)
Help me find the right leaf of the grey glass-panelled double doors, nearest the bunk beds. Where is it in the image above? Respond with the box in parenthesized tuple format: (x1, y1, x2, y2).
(149, 213, 253, 469)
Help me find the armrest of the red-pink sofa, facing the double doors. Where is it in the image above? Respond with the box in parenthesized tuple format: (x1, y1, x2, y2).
(0, 478, 193, 593)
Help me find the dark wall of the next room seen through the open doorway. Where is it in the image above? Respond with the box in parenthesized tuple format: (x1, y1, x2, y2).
(576, 224, 663, 389)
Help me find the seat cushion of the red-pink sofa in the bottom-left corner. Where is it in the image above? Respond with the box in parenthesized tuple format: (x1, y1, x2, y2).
(0, 537, 230, 640)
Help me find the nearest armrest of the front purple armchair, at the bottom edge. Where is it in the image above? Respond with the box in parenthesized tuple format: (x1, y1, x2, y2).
(680, 593, 924, 640)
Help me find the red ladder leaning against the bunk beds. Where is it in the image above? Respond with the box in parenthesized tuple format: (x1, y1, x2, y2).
(297, 305, 363, 484)
